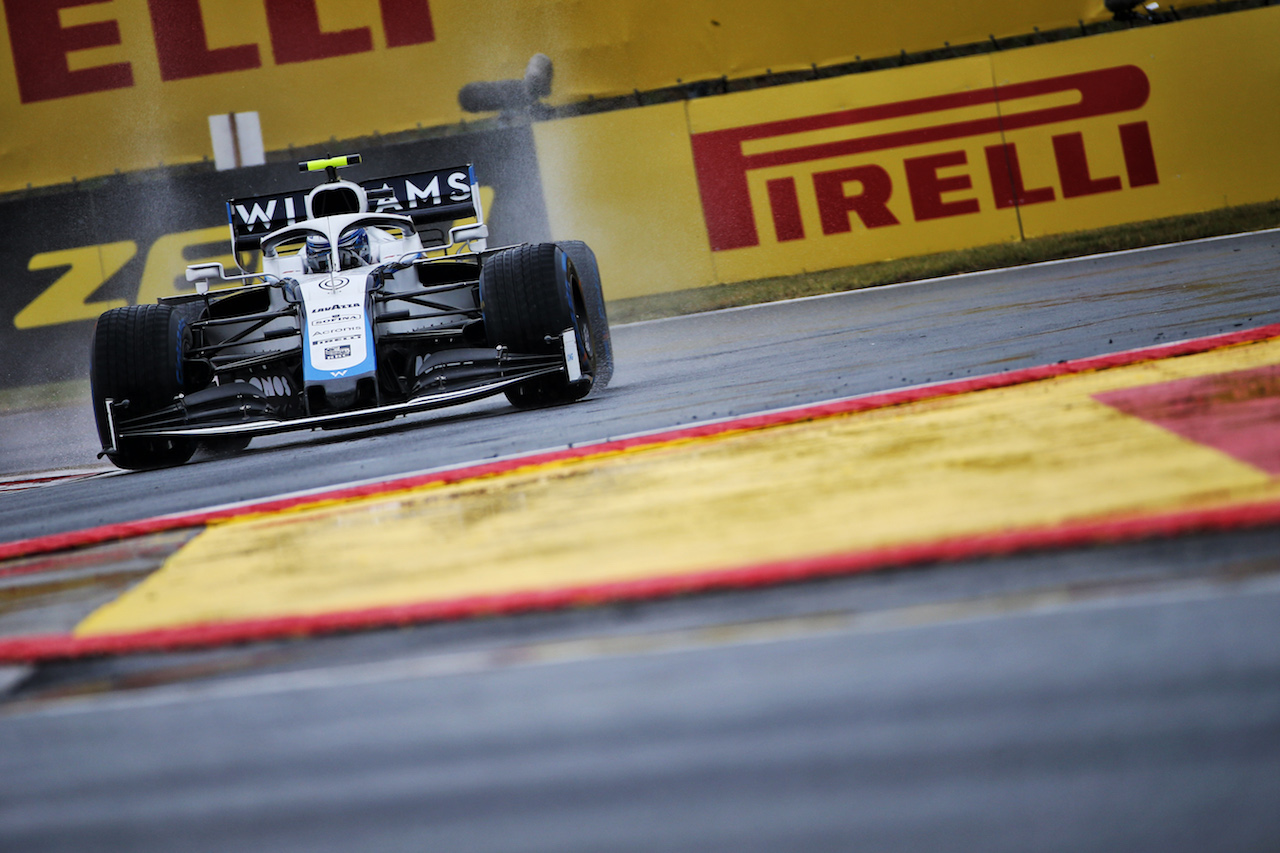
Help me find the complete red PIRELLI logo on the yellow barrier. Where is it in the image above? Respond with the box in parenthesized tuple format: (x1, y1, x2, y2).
(692, 65, 1160, 251)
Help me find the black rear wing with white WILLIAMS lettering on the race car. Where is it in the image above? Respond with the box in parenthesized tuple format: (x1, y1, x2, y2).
(227, 164, 486, 254)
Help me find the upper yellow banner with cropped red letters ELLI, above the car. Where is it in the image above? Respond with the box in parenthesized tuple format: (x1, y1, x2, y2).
(0, 0, 1110, 193)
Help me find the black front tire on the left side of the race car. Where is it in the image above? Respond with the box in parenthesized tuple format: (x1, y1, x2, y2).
(90, 305, 196, 469)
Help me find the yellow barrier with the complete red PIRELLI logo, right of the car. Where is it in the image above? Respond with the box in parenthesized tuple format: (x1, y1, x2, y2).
(534, 8, 1280, 298)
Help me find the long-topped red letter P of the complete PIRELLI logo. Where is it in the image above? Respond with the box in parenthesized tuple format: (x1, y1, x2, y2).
(691, 65, 1155, 251)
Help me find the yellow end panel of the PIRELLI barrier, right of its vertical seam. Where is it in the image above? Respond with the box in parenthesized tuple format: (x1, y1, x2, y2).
(993, 8, 1280, 237)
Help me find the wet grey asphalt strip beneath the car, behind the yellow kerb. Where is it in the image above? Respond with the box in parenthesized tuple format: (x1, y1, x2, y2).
(0, 225, 1280, 539)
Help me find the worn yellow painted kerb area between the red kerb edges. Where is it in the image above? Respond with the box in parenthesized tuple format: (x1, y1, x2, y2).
(77, 342, 1280, 635)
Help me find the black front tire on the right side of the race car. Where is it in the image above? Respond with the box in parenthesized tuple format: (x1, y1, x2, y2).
(480, 243, 596, 409)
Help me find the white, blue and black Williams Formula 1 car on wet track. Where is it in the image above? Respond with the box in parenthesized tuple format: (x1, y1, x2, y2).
(91, 155, 613, 469)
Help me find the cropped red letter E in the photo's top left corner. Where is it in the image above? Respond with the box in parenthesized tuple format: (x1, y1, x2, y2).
(4, 0, 133, 104)
